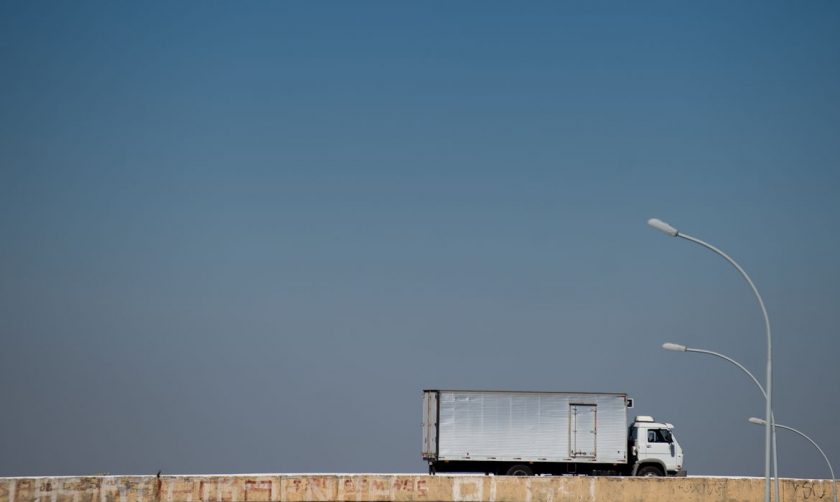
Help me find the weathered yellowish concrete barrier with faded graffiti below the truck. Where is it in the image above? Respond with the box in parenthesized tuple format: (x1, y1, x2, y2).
(0, 474, 832, 502)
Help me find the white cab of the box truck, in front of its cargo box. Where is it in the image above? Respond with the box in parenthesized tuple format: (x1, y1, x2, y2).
(628, 415, 686, 476)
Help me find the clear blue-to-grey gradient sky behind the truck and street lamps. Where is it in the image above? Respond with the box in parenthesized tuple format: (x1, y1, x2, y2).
(0, 1, 840, 477)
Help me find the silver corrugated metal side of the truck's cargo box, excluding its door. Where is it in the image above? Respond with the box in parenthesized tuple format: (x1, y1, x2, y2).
(437, 391, 627, 463)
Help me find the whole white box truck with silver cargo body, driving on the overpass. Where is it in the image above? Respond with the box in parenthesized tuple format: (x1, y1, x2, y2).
(423, 390, 686, 476)
